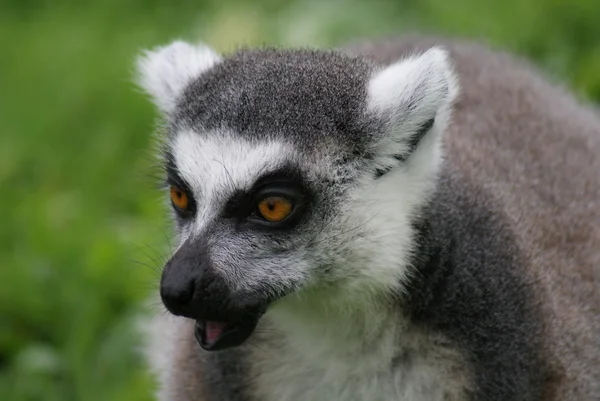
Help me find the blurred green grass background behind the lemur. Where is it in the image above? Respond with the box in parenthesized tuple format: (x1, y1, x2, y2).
(0, 0, 600, 401)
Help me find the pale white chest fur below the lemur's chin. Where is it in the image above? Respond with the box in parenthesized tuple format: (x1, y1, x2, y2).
(247, 309, 470, 401)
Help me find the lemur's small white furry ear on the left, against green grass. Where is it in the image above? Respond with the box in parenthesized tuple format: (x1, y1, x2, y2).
(137, 41, 221, 114)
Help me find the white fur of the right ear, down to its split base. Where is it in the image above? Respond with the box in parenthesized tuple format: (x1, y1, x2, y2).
(367, 47, 459, 178)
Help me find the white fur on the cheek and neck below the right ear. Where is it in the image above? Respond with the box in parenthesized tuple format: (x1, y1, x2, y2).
(340, 110, 452, 293)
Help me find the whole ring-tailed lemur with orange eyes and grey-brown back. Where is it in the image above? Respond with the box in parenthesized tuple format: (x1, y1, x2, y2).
(138, 36, 600, 401)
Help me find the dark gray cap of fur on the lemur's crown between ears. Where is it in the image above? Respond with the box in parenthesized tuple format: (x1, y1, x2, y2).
(173, 49, 377, 153)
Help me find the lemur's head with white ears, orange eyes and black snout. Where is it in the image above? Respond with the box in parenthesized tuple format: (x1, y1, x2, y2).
(138, 42, 457, 349)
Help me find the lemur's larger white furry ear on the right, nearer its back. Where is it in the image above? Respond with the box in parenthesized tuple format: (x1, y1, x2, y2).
(367, 47, 458, 169)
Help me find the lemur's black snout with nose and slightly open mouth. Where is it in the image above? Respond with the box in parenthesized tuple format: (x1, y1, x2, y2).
(160, 239, 265, 350)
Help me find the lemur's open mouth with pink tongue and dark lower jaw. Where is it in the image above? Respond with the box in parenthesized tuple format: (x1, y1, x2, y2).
(194, 320, 257, 351)
